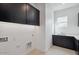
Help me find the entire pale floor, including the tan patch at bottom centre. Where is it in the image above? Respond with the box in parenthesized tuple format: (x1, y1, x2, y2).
(30, 46, 76, 55)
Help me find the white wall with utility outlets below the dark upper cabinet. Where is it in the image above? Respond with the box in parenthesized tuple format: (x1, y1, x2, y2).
(0, 22, 34, 54)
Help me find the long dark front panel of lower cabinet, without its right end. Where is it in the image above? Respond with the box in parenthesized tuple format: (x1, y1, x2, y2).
(52, 35, 75, 50)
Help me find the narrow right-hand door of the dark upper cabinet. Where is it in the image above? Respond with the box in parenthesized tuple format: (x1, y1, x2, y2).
(26, 4, 39, 25)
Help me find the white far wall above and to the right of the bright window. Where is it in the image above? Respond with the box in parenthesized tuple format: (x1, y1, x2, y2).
(55, 5, 79, 35)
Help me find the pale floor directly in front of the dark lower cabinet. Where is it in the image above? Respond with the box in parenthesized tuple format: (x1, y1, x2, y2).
(46, 46, 76, 55)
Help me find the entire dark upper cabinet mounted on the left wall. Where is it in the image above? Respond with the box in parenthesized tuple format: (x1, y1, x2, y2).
(0, 3, 40, 25)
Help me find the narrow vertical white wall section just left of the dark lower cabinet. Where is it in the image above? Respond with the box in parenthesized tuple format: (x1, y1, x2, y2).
(45, 3, 54, 50)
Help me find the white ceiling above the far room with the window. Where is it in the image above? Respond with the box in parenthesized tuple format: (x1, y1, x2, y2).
(50, 3, 79, 11)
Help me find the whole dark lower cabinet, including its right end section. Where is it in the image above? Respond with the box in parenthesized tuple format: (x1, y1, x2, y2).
(52, 35, 79, 55)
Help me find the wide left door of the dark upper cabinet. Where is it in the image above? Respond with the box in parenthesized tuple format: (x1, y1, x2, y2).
(0, 3, 26, 24)
